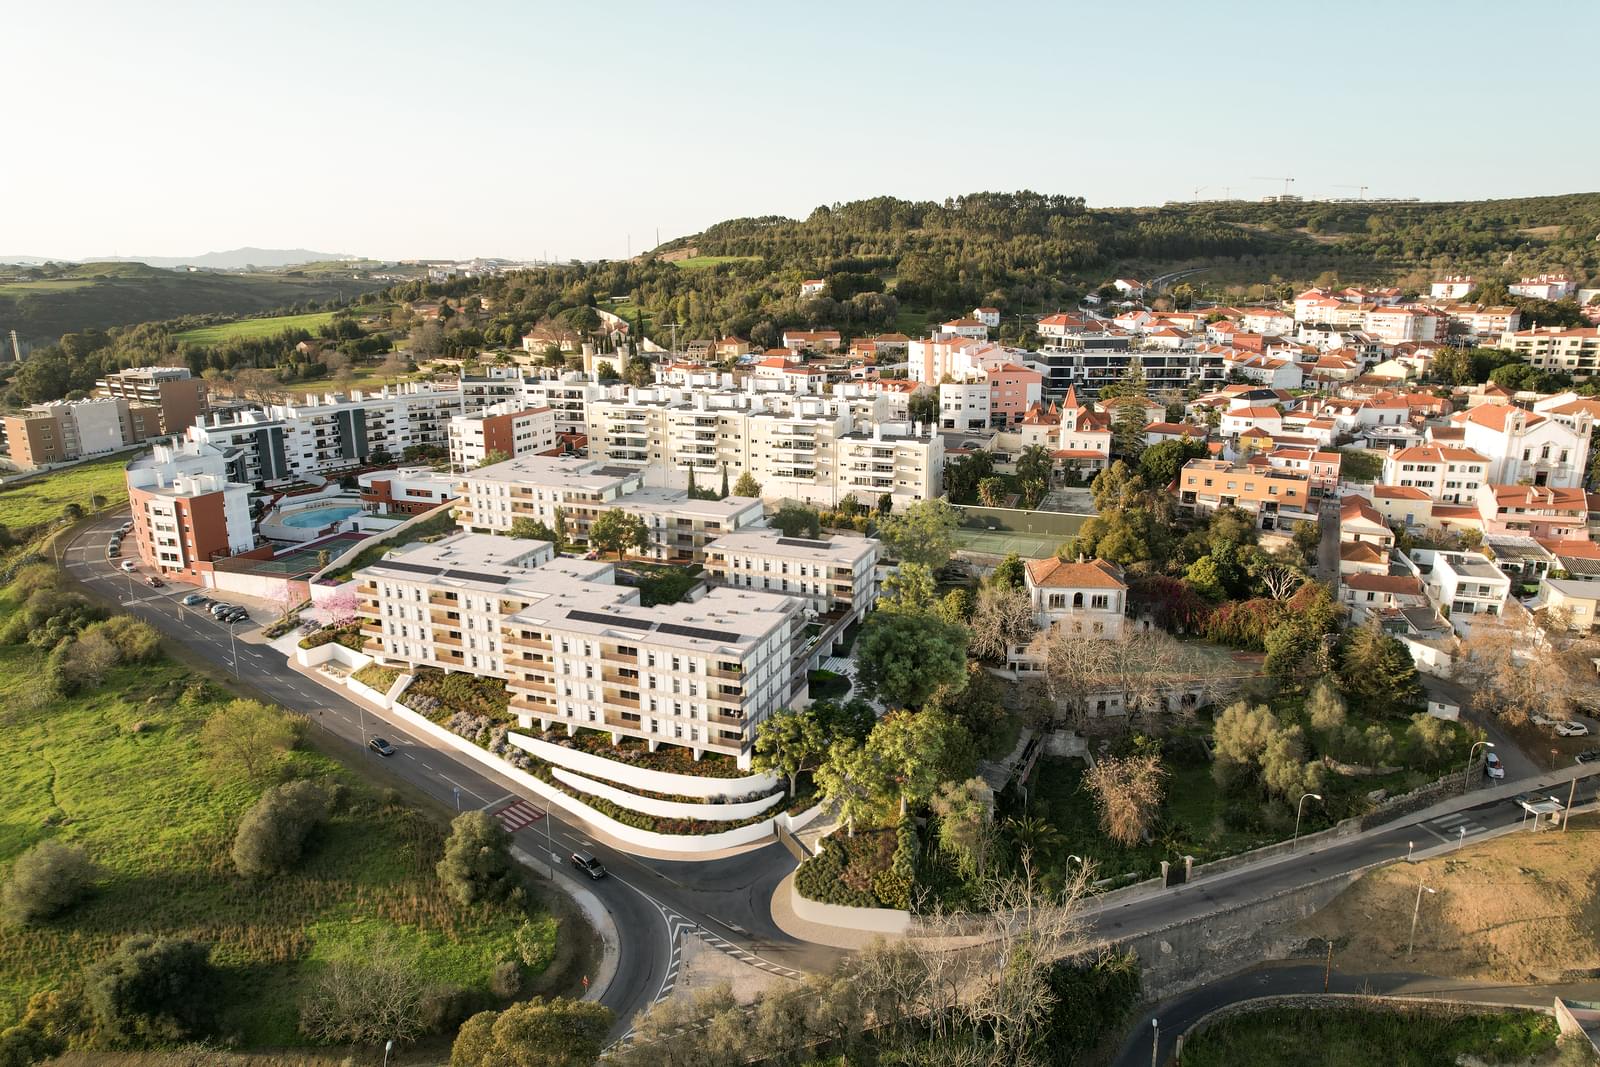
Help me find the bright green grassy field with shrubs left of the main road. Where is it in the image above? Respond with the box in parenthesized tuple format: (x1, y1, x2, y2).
(0, 579, 557, 1048)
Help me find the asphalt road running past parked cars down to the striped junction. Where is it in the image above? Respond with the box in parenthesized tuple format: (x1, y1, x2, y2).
(62, 512, 842, 1037)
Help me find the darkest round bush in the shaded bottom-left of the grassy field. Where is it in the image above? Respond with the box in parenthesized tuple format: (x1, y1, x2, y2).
(83, 934, 218, 1043)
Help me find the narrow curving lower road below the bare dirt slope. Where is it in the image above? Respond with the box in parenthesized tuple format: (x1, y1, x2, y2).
(1114, 960, 1600, 1067)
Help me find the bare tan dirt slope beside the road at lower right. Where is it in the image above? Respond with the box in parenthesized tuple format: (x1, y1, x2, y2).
(1299, 816, 1600, 982)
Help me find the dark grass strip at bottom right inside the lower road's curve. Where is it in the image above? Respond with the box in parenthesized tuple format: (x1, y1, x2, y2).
(1184, 1008, 1557, 1067)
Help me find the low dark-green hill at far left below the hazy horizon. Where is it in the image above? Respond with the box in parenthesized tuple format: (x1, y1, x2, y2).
(0, 260, 384, 344)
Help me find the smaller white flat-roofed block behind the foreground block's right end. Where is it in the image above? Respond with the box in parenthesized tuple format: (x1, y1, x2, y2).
(706, 528, 878, 621)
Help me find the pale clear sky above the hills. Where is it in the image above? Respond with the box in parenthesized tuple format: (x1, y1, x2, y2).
(0, 0, 1600, 259)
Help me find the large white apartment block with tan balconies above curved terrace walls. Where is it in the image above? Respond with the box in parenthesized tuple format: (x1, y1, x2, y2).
(355, 534, 806, 766)
